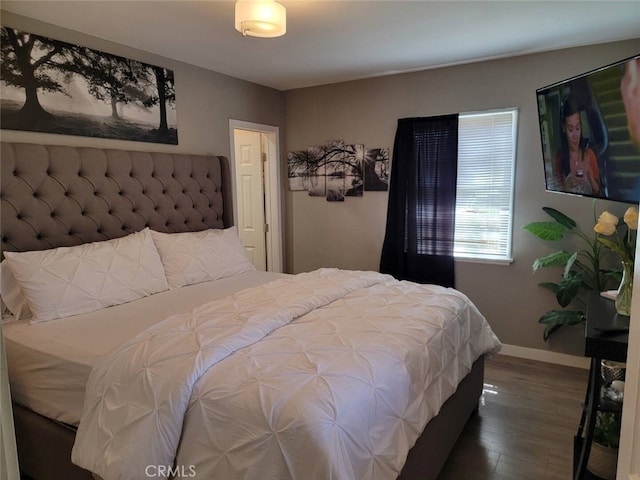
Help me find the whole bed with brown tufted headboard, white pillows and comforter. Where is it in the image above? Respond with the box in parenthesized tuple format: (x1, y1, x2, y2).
(0, 142, 500, 480)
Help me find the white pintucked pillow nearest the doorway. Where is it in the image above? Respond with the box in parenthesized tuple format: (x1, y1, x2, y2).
(151, 227, 255, 289)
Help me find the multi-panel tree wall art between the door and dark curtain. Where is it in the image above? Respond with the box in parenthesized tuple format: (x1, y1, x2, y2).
(287, 140, 389, 202)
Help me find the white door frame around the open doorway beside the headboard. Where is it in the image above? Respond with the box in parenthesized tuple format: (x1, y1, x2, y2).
(229, 119, 284, 273)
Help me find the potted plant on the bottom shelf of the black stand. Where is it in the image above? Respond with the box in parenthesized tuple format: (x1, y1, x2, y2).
(587, 411, 622, 480)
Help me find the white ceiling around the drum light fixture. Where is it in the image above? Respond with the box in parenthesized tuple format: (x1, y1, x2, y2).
(0, 0, 640, 90)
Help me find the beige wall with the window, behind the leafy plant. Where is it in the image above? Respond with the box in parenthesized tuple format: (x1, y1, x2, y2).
(285, 39, 640, 356)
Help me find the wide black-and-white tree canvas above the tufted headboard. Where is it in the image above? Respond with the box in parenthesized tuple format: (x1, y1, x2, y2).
(0, 26, 178, 145)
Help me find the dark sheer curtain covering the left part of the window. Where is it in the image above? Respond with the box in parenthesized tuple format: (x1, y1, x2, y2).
(380, 114, 458, 287)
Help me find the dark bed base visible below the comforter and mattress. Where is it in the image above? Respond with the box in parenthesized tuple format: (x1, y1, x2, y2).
(13, 357, 484, 480)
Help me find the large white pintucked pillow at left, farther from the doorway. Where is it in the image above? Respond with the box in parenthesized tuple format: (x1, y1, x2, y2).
(5, 229, 168, 323)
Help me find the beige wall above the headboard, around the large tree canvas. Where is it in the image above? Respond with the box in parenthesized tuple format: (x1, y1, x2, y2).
(1, 11, 284, 160)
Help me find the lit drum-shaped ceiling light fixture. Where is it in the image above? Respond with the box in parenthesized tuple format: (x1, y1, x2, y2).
(235, 0, 287, 38)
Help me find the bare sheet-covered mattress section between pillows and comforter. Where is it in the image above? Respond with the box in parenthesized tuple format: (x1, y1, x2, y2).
(2, 271, 284, 425)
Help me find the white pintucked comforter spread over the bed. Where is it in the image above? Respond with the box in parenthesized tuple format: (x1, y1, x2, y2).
(72, 269, 500, 480)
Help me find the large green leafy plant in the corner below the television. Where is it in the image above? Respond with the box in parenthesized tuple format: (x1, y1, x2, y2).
(522, 201, 620, 340)
